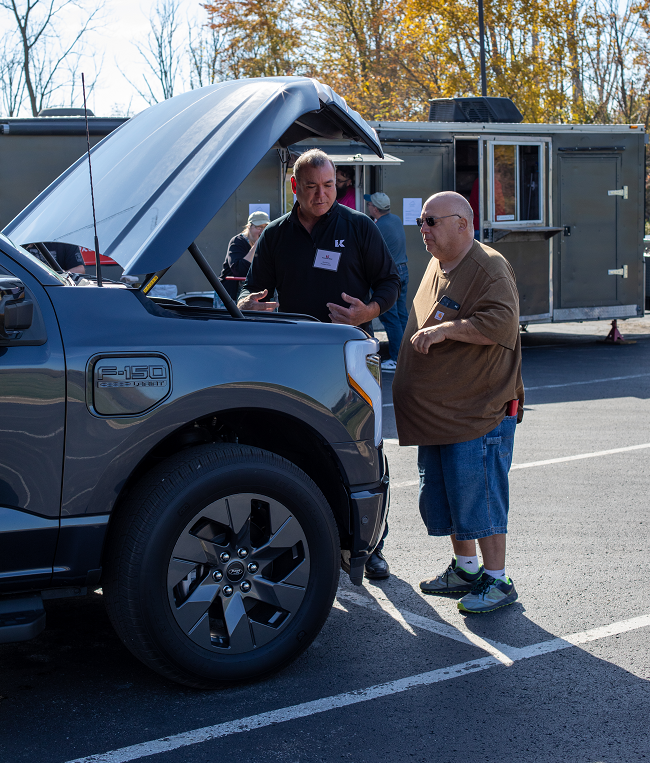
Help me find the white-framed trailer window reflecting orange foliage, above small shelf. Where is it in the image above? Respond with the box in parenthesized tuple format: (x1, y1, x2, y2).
(490, 143, 542, 223)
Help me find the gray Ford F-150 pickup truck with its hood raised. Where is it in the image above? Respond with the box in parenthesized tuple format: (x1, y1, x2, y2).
(0, 77, 389, 687)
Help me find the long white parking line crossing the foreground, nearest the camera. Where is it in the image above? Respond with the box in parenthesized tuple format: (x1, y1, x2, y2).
(63, 615, 650, 763)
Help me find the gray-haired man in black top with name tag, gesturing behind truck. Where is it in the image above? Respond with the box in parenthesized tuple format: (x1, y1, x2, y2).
(238, 149, 400, 579)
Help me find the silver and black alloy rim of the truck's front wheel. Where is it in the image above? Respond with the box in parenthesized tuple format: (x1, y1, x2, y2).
(167, 493, 310, 654)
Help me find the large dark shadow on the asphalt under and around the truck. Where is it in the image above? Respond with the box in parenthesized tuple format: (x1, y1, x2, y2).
(0, 577, 649, 763)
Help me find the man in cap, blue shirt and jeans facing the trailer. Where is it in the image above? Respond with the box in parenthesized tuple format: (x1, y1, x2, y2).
(363, 193, 409, 371)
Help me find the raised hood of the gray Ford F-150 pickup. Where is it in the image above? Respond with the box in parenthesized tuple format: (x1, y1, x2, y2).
(3, 77, 383, 275)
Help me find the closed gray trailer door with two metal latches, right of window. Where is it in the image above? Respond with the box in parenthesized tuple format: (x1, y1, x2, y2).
(556, 153, 625, 309)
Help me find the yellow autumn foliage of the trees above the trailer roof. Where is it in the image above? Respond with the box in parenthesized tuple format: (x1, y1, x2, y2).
(205, 0, 650, 127)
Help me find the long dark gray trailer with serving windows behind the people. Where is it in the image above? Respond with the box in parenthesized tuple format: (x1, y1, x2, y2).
(0, 98, 647, 324)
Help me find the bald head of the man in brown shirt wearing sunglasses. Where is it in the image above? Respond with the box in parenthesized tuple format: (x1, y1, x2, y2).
(421, 191, 474, 271)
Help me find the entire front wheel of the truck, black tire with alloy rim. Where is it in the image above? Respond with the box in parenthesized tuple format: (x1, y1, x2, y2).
(104, 445, 340, 688)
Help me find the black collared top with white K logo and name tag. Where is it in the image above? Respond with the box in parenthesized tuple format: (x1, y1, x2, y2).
(240, 201, 400, 323)
